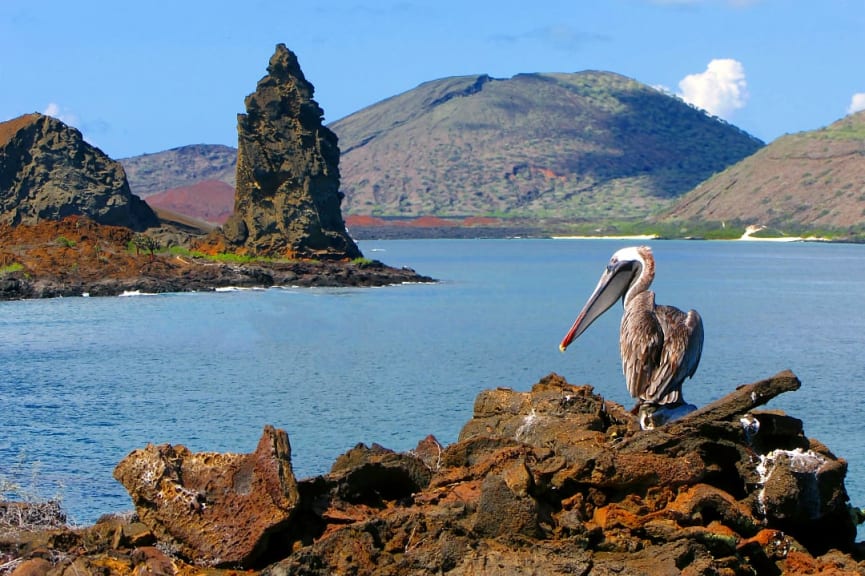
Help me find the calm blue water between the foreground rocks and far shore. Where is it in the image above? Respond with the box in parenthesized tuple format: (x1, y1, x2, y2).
(0, 239, 865, 523)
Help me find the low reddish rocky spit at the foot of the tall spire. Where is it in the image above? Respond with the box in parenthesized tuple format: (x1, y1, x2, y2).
(0, 216, 434, 300)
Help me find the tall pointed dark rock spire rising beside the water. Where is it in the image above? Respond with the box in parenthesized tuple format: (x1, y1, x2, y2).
(223, 44, 361, 259)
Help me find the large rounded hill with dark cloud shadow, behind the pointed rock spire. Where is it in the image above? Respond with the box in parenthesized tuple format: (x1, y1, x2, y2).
(331, 71, 762, 219)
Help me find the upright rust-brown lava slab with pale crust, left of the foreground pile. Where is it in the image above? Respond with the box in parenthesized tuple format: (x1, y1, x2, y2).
(114, 426, 298, 566)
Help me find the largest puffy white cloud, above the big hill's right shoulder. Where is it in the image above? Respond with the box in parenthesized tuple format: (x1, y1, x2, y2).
(679, 58, 748, 119)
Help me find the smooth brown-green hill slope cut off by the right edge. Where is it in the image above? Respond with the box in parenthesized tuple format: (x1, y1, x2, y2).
(662, 111, 865, 230)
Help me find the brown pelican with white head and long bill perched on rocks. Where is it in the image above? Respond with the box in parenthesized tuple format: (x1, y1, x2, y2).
(559, 246, 703, 429)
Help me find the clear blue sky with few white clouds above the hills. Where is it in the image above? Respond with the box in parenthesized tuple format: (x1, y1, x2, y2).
(0, 0, 865, 158)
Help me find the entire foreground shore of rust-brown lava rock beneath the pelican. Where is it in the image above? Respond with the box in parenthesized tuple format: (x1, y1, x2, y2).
(0, 371, 865, 576)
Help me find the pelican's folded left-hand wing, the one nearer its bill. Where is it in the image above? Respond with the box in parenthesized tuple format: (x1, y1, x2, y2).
(619, 302, 664, 399)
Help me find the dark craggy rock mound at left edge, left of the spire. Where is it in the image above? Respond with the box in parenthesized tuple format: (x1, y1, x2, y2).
(0, 114, 159, 230)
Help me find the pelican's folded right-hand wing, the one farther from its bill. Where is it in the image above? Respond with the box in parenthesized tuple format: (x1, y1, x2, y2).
(644, 306, 703, 404)
